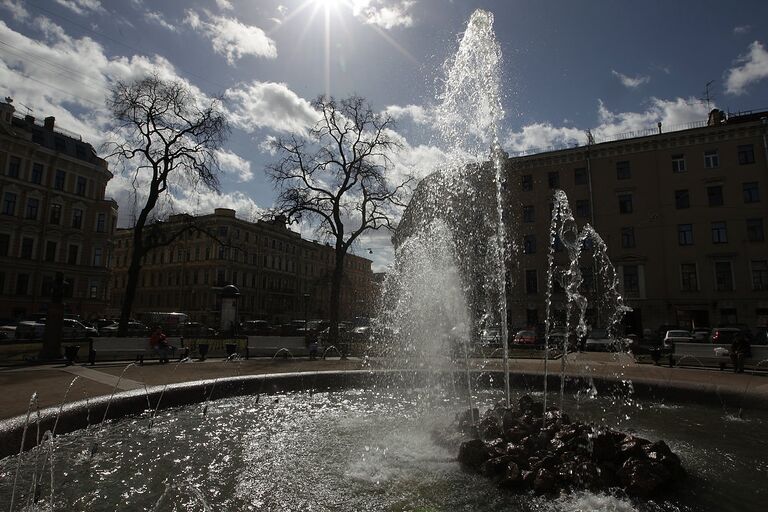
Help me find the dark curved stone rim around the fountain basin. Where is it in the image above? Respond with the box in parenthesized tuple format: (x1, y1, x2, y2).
(0, 370, 768, 459)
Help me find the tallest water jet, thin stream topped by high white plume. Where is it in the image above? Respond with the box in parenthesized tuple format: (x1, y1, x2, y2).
(438, 9, 509, 405)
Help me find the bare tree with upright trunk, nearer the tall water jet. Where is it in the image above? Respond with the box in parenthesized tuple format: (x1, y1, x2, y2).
(267, 96, 411, 342)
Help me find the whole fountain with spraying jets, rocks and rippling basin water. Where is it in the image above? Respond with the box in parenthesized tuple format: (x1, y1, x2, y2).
(0, 11, 768, 512)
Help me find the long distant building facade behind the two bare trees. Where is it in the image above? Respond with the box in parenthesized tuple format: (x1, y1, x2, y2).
(110, 208, 372, 327)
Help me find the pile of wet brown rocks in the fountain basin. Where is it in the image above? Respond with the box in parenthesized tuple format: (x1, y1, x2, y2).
(434, 395, 685, 498)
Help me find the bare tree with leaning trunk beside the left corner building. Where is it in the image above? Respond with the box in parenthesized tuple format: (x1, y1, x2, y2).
(106, 75, 229, 334)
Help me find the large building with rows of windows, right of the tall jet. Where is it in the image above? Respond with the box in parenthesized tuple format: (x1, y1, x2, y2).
(507, 111, 768, 334)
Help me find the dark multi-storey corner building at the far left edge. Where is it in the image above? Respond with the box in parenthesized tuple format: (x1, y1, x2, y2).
(0, 98, 117, 319)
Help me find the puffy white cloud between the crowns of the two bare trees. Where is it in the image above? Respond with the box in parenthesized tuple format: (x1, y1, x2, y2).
(224, 81, 319, 133)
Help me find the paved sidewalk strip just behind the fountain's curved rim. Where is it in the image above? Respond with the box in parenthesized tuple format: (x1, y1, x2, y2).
(0, 353, 768, 419)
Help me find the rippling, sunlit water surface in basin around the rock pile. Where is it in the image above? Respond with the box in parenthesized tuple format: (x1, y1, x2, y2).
(0, 390, 768, 512)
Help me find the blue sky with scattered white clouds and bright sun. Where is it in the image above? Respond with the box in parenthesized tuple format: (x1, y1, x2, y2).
(0, 0, 768, 271)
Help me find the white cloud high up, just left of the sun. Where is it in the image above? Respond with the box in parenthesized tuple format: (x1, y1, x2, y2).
(184, 10, 277, 65)
